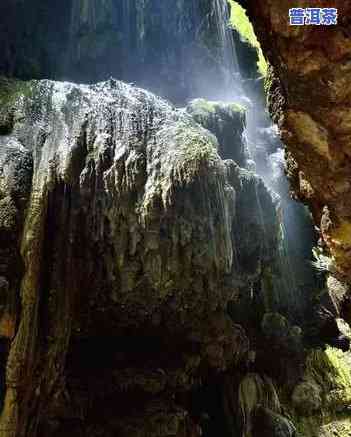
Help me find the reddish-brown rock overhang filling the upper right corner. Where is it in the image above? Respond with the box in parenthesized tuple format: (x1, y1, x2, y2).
(241, 1, 351, 280)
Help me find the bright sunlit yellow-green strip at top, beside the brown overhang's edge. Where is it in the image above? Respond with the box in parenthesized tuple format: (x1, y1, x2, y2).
(229, 0, 268, 76)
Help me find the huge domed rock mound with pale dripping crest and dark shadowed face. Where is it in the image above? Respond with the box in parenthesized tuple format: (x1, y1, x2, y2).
(0, 80, 290, 437)
